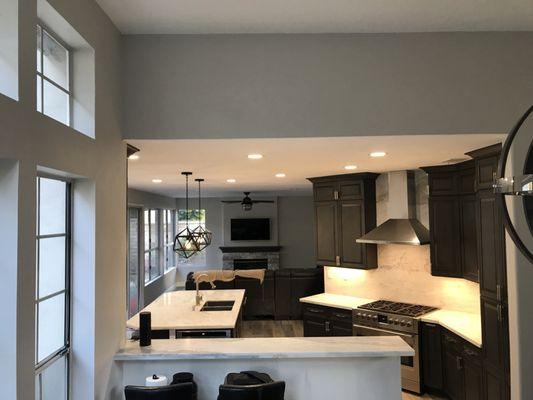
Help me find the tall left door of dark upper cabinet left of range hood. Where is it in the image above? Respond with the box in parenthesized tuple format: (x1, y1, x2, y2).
(315, 201, 337, 265)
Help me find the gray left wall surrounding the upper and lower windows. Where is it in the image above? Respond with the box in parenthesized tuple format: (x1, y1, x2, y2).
(0, 0, 126, 400)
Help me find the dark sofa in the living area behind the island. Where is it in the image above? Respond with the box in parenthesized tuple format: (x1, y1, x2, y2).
(185, 267, 324, 320)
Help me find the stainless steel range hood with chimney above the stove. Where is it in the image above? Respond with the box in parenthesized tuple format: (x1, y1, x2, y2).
(356, 171, 429, 245)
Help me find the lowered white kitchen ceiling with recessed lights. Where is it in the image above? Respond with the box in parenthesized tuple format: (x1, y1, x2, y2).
(128, 134, 505, 198)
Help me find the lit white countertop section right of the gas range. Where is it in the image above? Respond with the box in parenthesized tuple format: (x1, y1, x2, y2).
(420, 310, 482, 348)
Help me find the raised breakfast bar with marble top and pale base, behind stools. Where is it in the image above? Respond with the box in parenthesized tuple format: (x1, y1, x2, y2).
(115, 336, 414, 400)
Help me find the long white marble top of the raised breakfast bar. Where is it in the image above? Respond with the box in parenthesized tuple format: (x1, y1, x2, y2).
(115, 336, 414, 361)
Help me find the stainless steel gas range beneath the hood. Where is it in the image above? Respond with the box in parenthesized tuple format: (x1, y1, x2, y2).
(353, 300, 436, 393)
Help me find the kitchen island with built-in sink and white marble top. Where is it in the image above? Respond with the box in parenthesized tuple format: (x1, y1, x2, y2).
(126, 289, 245, 339)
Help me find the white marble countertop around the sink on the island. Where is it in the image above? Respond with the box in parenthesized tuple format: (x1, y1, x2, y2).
(126, 289, 244, 330)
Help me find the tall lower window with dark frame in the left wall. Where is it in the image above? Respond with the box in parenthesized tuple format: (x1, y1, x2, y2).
(35, 177, 70, 400)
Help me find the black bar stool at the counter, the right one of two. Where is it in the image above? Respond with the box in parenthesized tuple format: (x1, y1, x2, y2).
(218, 371, 285, 400)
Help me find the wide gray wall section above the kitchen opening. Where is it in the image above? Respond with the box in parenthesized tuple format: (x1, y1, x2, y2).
(122, 32, 533, 139)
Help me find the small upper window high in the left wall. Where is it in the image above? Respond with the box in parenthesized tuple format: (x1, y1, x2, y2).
(37, 25, 72, 125)
